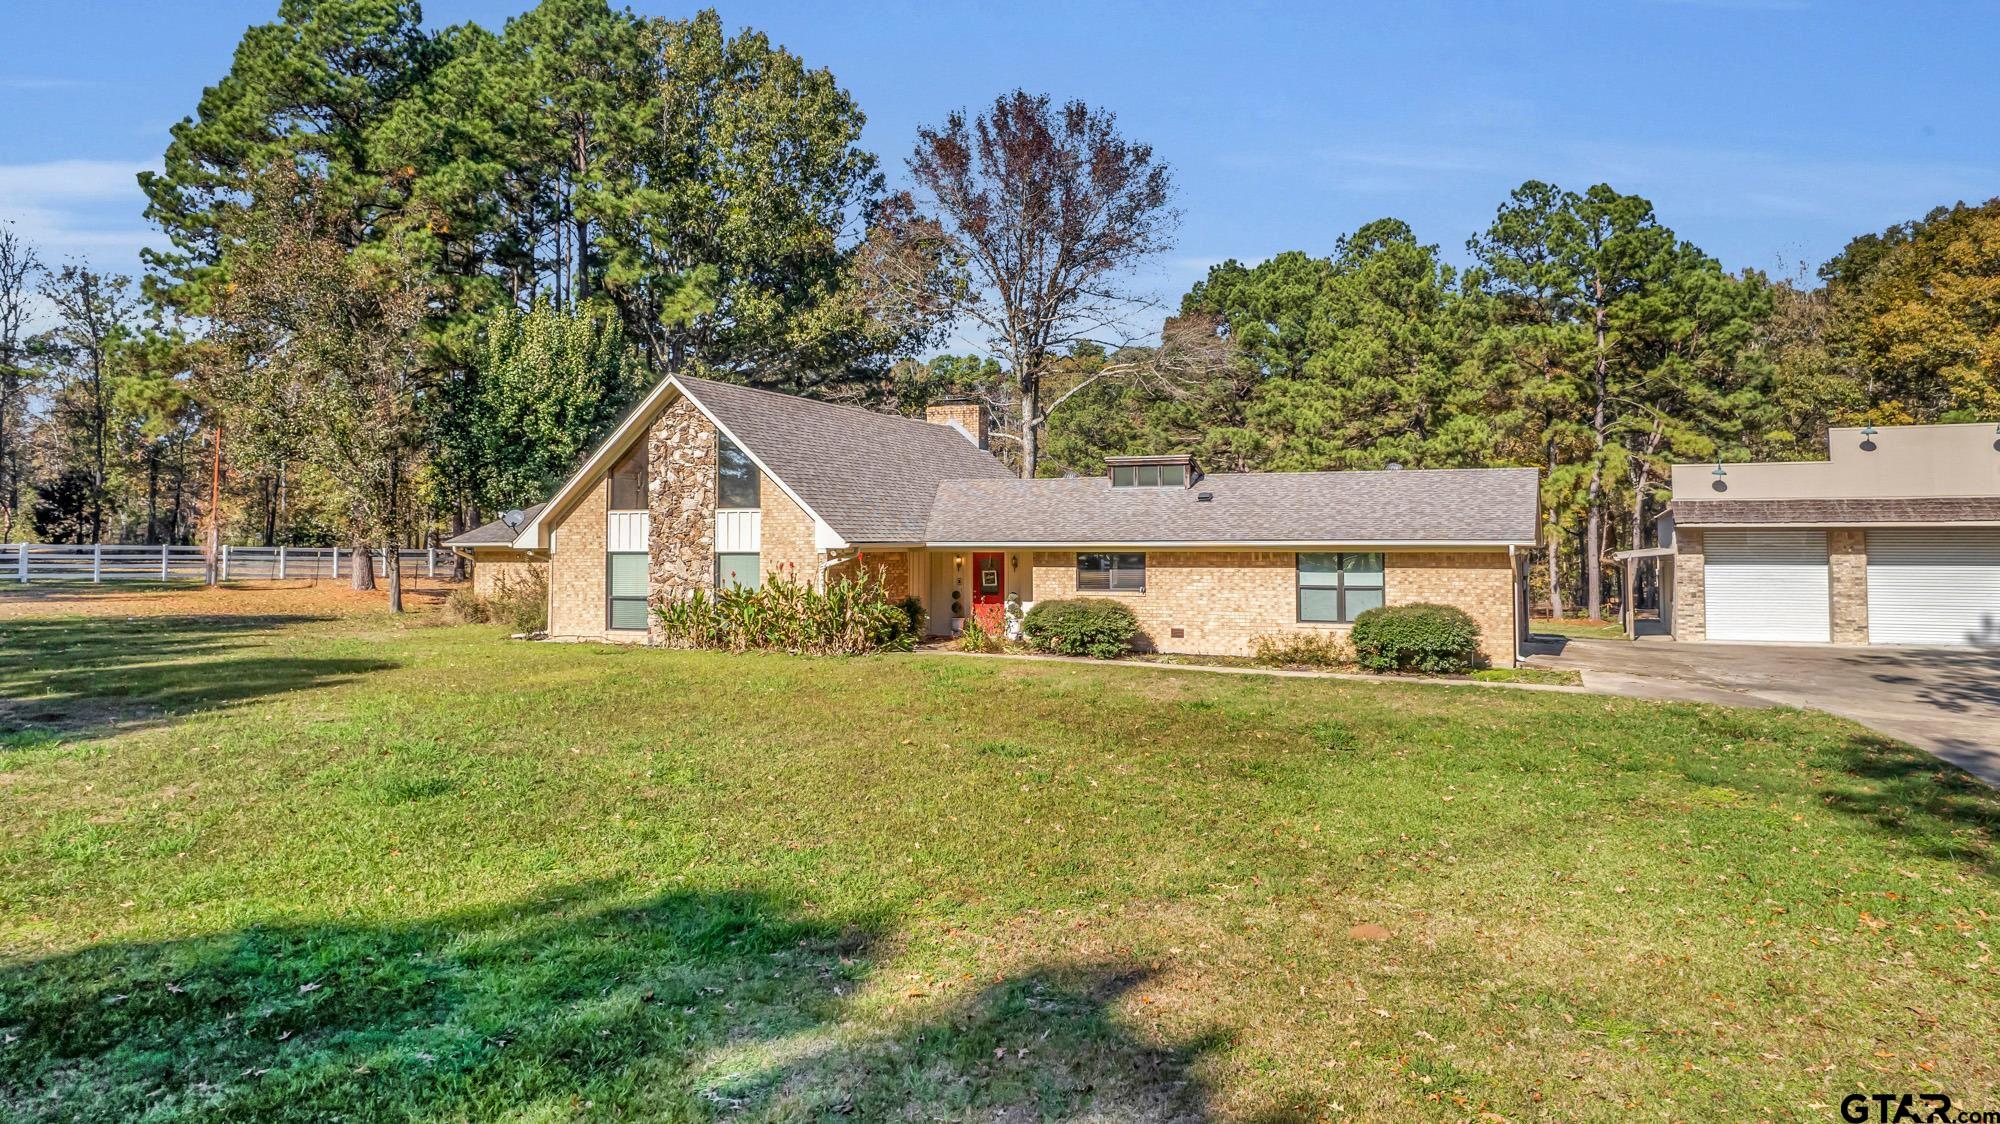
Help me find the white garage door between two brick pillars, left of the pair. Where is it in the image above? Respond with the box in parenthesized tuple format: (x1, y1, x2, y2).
(1702, 530, 1834, 644)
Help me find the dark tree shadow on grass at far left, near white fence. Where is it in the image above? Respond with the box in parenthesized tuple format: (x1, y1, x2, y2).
(0, 616, 388, 750)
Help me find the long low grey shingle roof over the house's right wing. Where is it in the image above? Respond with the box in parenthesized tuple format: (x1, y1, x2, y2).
(926, 468, 1540, 546)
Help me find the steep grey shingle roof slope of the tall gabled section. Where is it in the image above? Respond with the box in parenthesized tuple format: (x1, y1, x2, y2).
(680, 376, 1014, 542)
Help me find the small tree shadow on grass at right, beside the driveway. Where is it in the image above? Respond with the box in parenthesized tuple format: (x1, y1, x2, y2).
(1824, 734, 2000, 878)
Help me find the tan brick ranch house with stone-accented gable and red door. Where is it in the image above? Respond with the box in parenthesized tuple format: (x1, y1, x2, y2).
(450, 368, 1538, 666)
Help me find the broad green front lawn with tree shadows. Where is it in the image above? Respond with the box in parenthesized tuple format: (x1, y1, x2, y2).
(0, 616, 2000, 1120)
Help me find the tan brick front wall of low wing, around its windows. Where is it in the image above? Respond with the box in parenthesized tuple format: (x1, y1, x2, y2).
(1034, 550, 1514, 666)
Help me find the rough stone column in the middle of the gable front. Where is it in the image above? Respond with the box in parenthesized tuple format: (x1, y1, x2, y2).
(646, 398, 716, 644)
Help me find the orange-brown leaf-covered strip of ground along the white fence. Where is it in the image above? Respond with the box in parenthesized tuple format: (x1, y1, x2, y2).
(0, 578, 456, 620)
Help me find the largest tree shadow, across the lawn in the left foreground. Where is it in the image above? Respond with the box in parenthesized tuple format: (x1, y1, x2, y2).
(0, 884, 1208, 1120)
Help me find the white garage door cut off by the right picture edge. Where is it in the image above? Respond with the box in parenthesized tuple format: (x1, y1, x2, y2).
(1868, 530, 2000, 644)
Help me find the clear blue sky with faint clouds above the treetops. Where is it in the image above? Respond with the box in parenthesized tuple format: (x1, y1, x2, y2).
(0, 0, 2000, 336)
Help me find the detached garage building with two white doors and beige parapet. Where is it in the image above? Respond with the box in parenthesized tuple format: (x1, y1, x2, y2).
(1646, 424, 2000, 646)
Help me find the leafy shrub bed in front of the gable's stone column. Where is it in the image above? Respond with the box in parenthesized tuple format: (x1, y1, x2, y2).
(654, 574, 916, 656)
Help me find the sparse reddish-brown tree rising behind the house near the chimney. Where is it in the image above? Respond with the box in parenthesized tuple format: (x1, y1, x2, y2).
(910, 90, 1180, 476)
